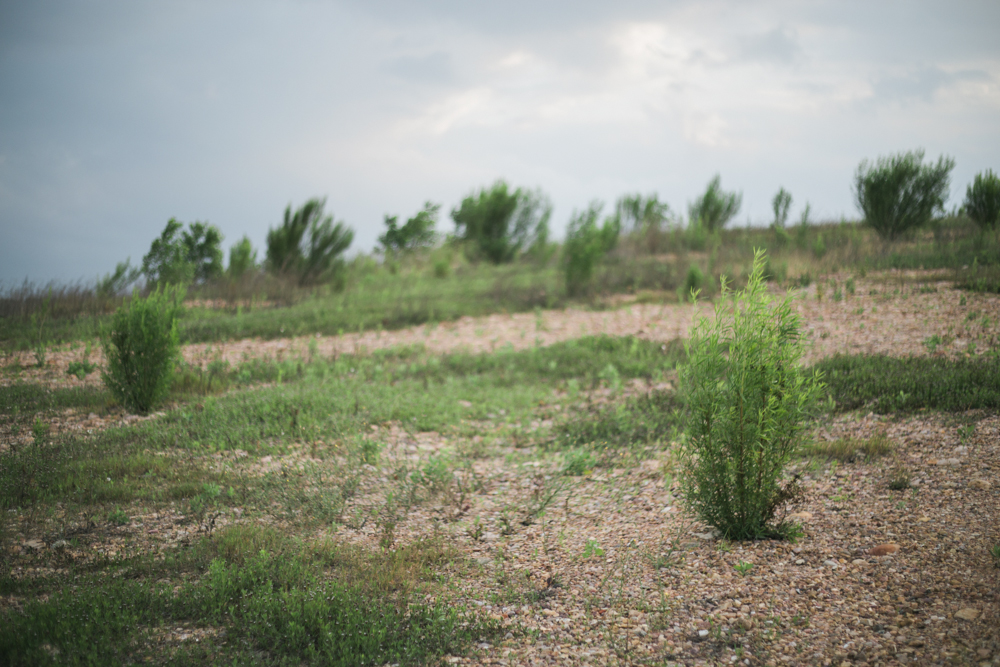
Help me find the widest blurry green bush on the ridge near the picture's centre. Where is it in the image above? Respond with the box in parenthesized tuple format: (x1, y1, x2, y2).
(451, 180, 552, 264)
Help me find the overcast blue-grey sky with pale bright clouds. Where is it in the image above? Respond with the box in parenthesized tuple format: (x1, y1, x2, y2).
(0, 0, 1000, 287)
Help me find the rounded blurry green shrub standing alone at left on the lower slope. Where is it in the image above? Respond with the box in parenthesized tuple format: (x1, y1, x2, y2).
(101, 287, 184, 414)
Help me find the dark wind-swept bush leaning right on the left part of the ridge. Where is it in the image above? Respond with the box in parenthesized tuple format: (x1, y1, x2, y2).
(266, 199, 354, 285)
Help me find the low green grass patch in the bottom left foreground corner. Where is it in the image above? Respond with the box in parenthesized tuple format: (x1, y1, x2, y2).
(0, 550, 500, 665)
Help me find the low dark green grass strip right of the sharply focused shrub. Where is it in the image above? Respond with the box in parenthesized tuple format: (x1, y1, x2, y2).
(814, 355, 1000, 414)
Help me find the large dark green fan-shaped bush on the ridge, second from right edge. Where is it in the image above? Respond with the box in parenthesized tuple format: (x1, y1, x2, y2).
(854, 150, 955, 241)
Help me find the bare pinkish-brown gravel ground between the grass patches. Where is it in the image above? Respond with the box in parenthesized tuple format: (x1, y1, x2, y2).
(3, 272, 1000, 665)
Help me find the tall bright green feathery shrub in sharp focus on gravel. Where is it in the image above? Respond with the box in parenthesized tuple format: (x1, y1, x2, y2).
(680, 251, 822, 540)
